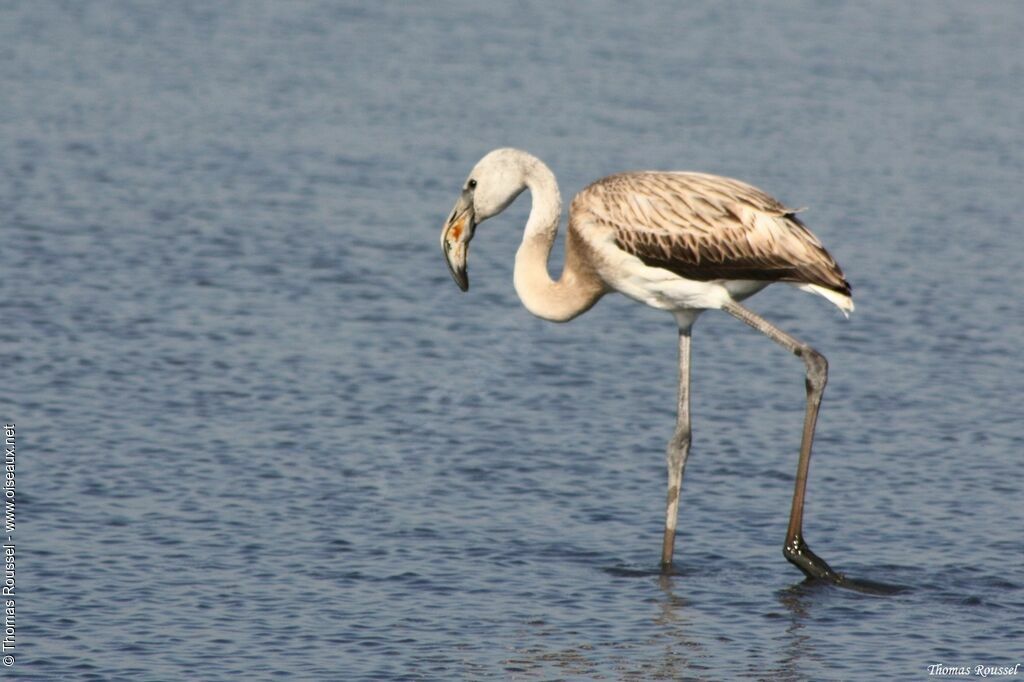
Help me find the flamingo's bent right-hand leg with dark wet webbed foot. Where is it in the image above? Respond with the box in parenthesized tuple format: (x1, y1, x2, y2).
(723, 302, 844, 583)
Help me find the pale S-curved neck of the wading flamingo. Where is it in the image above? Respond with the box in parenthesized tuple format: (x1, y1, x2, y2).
(514, 158, 604, 322)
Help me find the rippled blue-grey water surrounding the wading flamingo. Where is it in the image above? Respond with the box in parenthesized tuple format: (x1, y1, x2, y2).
(0, 2, 1024, 680)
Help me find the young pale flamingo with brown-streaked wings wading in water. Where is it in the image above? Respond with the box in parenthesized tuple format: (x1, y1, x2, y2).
(440, 148, 853, 583)
